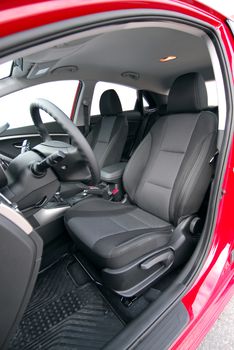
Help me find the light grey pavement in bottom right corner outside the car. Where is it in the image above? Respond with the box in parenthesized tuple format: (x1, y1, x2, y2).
(198, 297, 234, 350)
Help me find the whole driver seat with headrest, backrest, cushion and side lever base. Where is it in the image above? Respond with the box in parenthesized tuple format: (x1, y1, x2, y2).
(65, 73, 217, 297)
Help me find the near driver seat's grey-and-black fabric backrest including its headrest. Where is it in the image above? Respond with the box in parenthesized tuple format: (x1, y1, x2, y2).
(124, 73, 218, 225)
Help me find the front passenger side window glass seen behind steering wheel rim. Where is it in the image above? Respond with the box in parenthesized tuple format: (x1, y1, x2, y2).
(0, 80, 79, 129)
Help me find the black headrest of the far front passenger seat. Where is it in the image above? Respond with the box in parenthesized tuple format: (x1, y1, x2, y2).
(99, 89, 122, 116)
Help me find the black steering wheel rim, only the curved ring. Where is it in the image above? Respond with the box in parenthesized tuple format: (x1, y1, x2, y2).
(30, 98, 100, 184)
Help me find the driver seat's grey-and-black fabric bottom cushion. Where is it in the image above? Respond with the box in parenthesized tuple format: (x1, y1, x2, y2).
(65, 197, 173, 268)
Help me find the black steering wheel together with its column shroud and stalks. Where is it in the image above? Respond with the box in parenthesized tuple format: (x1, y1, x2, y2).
(0, 99, 100, 215)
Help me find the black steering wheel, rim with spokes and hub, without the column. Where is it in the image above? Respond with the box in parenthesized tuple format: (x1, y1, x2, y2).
(30, 98, 100, 185)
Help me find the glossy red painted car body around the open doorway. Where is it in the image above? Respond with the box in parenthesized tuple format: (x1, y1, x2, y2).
(0, 0, 234, 349)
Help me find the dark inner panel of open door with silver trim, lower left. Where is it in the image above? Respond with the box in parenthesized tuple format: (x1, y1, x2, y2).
(0, 203, 43, 350)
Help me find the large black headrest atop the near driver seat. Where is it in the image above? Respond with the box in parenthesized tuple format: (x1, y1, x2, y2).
(167, 73, 207, 113)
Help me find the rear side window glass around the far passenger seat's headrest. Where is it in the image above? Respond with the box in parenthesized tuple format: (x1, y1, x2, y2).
(91, 81, 137, 115)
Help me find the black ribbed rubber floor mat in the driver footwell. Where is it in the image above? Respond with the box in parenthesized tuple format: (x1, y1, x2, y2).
(9, 255, 124, 350)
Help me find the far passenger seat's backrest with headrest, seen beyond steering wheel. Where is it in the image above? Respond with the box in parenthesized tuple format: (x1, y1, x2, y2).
(87, 89, 128, 168)
